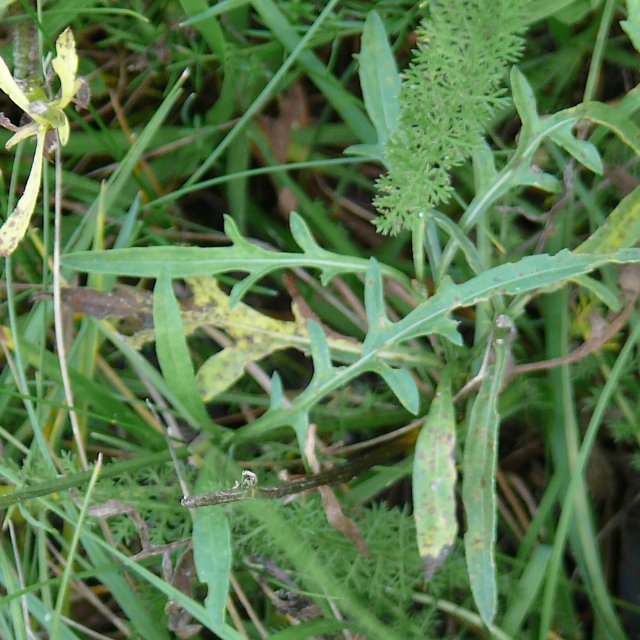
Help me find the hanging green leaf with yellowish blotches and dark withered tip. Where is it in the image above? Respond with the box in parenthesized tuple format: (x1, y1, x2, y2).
(413, 369, 458, 582)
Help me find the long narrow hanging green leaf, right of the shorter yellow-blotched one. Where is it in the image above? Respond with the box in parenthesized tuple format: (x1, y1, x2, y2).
(462, 315, 513, 625)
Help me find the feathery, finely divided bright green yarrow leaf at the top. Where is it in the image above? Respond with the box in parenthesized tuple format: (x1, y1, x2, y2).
(375, 0, 529, 234)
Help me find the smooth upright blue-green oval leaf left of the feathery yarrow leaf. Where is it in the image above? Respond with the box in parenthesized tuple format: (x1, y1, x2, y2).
(358, 11, 400, 152)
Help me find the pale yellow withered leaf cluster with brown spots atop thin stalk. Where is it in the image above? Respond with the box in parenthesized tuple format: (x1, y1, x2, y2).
(0, 27, 82, 256)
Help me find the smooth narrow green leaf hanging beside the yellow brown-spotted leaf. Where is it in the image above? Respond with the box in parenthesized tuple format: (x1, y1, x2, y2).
(153, 269, 211, 428)
